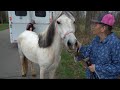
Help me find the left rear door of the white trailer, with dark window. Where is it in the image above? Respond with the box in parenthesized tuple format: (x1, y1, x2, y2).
(10, 11, 31, 43)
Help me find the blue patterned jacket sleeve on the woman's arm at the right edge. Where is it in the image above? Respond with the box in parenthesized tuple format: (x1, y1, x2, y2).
(95, 42, 120, 77)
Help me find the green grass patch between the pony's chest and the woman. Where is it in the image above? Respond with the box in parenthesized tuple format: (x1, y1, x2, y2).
(56, 50, 85, 79)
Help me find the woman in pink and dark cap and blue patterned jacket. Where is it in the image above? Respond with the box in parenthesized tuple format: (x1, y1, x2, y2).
(75, 13, 120, 79)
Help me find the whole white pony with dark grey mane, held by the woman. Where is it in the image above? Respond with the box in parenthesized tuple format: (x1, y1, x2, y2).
(18, 11, 78, 79)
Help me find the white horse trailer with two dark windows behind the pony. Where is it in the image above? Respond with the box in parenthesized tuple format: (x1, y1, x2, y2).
(8, 11, 57, 43)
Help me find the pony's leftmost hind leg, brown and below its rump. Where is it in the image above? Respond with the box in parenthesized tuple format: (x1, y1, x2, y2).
(20, 56, 28, 77)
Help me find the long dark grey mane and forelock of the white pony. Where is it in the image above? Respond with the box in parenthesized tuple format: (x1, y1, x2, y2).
(38, 11, 74, 48)
